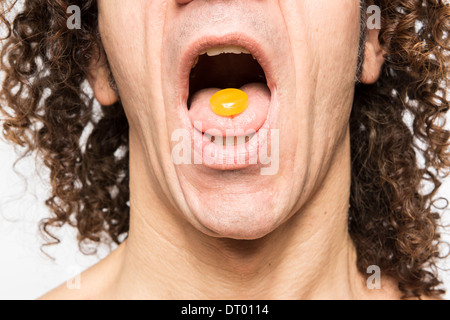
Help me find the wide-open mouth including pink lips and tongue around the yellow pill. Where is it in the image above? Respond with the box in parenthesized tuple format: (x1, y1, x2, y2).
(178, 33, 277, 170)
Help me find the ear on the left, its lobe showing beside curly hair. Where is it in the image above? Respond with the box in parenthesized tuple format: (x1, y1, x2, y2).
(87, 54, 119, 106)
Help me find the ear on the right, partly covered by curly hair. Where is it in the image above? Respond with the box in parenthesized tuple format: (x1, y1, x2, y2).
(360, 29, 385, 84)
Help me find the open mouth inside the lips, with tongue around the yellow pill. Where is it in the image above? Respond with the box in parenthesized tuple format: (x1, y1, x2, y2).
(187, 46, 271, 147)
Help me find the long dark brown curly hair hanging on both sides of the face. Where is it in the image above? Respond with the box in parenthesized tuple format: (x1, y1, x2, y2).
(0, 0, 450, 298)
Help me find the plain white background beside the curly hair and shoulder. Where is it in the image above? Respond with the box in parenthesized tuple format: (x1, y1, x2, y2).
(0, 0, 450, 299)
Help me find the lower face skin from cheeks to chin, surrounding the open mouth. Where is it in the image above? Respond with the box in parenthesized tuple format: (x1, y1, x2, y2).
(96, 0, 359, 239)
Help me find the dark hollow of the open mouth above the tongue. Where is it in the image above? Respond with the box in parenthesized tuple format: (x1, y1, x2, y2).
(187, 53, 267, 109)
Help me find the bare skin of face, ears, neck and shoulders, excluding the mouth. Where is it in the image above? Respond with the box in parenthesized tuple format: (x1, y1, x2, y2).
(43, 0, 394, 299)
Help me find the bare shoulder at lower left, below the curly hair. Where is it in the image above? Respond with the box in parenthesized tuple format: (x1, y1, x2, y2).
(39, 247, 122, 300)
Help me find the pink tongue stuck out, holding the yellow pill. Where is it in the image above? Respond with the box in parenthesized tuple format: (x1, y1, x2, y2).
(189, 83, 270, 136)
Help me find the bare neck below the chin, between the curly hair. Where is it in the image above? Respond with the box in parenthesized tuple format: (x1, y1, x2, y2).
(106, 129, 367, 299)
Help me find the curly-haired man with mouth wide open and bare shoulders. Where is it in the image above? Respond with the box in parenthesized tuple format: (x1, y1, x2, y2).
(1, 0, 449, 299)
